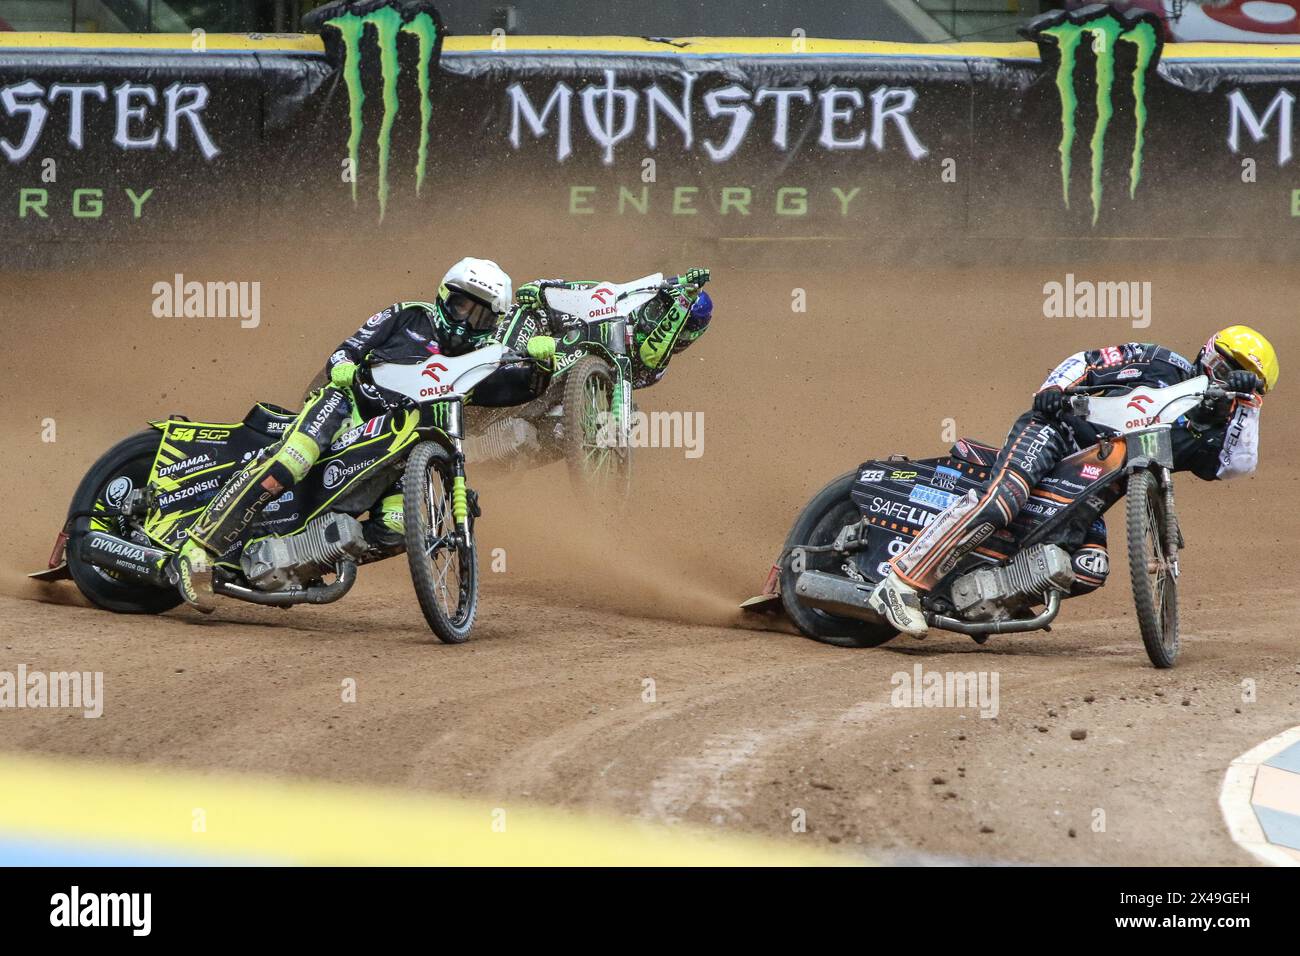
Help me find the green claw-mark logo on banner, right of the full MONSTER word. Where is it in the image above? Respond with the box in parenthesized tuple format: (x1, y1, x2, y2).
(1024, 7, 1164, 225)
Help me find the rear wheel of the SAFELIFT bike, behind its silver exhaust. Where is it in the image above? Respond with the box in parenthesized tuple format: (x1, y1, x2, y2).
(781, 471, 898, 648)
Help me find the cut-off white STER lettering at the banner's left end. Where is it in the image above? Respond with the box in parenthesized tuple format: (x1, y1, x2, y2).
(0, 79, 221, 163)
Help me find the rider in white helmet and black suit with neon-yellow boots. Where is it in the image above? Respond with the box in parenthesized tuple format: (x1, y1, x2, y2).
(173, 258, 555, 611)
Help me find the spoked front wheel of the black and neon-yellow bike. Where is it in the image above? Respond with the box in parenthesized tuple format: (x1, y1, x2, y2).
(402, 442, 478, 644)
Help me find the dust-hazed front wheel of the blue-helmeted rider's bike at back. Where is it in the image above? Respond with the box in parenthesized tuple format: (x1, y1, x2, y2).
(564, 355, 632, 499)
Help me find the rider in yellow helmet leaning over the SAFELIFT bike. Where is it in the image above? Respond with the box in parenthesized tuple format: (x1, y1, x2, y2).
(870, 325, 1278, 637)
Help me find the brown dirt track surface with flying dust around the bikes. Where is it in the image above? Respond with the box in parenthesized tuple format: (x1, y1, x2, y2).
(0, 246, 1300, 864)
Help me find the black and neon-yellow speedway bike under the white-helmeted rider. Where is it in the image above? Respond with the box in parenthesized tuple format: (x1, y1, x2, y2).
(31, 343, 530, 644)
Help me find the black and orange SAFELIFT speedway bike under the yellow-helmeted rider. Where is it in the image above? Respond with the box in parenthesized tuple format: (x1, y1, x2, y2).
(741, 376, 1247, 667)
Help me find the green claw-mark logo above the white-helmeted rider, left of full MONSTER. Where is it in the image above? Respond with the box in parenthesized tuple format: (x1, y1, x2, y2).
(322, 5, 442, 222)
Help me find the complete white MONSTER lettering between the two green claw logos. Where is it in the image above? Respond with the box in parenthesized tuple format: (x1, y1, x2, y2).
(506, 70, 930, 165)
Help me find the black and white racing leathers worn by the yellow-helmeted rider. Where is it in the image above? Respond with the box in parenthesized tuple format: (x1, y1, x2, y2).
(892, 342, 1260, 591)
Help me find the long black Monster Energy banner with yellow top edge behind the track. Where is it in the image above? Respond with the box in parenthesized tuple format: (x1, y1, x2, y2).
(0, 0, 1300, 254)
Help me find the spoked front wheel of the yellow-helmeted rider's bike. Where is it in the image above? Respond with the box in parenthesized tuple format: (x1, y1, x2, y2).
(1127, 471, 1179, 667)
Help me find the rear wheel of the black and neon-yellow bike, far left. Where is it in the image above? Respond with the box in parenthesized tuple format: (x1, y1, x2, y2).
(68, 431, 181, 614)
